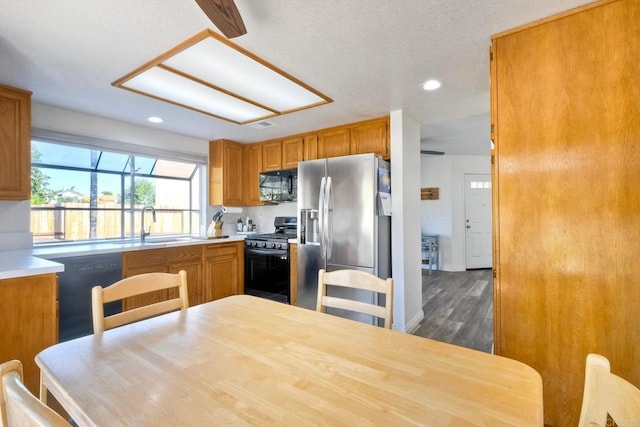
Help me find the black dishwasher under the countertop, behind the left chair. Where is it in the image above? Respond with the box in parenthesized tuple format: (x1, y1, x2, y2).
(51, 252, 122, 342)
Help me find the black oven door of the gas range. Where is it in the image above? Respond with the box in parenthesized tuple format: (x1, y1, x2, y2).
(244, 247, 291, 304)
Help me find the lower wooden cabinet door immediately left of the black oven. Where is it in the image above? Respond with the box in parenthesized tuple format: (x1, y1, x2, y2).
(204, 242, 244, 302)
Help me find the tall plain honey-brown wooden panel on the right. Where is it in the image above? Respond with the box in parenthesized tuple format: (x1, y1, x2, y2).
(492, 0, 640, 426)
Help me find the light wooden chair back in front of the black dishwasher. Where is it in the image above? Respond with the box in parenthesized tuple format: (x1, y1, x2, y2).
(91, 270, 189, 334)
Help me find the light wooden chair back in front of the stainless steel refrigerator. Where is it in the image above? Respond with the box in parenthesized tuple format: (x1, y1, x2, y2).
(316, 270, 393, 329)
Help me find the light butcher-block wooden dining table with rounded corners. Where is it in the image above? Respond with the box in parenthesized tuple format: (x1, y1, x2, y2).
(36, 295, 543, 426)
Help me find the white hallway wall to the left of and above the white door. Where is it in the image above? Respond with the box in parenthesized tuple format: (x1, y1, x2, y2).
(420, 155, 491, 271)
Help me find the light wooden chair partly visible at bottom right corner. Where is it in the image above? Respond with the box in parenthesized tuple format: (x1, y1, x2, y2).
(578, 354, 640, 427)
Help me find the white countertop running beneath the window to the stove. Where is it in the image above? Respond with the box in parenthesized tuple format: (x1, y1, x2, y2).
(0, 234, 245, 279)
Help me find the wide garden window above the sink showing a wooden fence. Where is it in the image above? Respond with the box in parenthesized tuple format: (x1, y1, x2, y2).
(31, 140, 203, 244)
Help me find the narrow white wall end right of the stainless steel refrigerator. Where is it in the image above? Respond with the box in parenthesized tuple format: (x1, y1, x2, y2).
(390, 110, 424, 332)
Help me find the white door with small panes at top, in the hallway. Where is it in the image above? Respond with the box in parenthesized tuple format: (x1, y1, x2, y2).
(464, 174, 492, 268)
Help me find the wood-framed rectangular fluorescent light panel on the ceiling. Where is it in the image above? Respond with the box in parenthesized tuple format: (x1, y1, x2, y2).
(113, 30, 332, 124)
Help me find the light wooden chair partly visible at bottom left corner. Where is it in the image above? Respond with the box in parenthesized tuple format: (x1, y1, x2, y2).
(0, 360, 70, 427)
